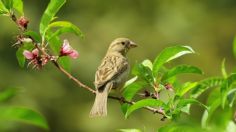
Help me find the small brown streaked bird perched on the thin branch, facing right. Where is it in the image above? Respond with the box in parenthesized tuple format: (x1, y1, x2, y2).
(90, 38, 137, 117)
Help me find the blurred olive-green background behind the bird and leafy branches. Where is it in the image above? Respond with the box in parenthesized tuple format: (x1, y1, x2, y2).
(0, 0, 236, 132)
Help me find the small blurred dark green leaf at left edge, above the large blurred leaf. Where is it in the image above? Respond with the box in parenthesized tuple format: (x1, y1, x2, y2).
(0, 88, 18, 102)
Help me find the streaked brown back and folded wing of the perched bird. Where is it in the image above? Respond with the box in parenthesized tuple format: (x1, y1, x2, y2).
(94, 56, 129, 89)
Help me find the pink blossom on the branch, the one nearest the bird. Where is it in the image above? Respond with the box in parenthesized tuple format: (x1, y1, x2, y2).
(60, 40, 79, 59)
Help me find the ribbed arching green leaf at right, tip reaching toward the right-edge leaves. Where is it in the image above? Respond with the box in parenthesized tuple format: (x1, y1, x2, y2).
(191, 77, 224, 98)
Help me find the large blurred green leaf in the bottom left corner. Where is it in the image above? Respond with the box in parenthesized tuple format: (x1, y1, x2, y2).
(0, 107, 48, 129)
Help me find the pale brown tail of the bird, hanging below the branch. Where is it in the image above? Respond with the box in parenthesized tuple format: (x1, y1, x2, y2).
(89, 90, 108, 117)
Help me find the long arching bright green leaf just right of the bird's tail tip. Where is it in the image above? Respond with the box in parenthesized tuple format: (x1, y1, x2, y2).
(125, 99, 167, 118)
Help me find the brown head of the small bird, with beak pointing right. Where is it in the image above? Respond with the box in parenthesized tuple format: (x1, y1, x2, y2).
(108, 38, 137, 55)
